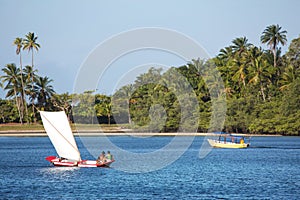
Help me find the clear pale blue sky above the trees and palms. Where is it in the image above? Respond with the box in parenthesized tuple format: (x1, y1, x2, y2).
(0, 0, 300, 98)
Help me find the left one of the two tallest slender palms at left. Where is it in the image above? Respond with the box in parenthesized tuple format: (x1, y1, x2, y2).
(13, 37, 28, 122)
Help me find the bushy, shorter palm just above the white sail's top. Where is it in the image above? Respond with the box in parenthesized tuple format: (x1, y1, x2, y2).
(34, 76, 55, 110)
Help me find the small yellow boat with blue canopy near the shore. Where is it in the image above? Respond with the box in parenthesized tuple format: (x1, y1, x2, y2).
(207, 134, 250, 148)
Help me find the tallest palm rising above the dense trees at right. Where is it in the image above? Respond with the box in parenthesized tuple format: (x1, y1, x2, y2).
(260, 24, 287, 67)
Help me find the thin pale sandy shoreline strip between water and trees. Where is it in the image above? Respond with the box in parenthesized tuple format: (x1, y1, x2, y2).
(0, 130, 282, 137)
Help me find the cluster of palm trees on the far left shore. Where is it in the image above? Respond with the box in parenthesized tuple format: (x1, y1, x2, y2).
(0, 32, 55, 124)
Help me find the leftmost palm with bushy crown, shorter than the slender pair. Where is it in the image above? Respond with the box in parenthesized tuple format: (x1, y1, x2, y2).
(1, 63, 23, 124)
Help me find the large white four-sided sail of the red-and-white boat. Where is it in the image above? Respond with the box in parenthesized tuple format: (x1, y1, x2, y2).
(40, 111, 81, 161)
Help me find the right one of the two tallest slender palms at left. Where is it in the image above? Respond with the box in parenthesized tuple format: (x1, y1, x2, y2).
(23, 32, 40, 121)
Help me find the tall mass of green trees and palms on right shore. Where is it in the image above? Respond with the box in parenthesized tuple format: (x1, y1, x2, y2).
(112, 25, 300, 135)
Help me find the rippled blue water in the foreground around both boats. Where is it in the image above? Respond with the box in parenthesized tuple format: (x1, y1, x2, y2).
(0, 136, 300, 199)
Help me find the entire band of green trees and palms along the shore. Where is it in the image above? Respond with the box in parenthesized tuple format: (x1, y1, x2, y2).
(0, 25, 300, 135)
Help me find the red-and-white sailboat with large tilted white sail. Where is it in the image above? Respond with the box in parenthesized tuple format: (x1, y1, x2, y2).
(40, 111, 114, 167)
